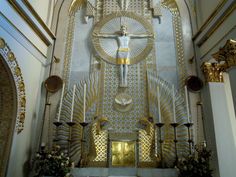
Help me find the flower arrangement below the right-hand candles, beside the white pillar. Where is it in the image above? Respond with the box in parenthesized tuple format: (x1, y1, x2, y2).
(177, 144, 212, 177)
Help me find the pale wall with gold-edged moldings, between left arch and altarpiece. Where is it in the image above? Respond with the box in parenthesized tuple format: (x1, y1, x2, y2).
(0, 0, 54, 177)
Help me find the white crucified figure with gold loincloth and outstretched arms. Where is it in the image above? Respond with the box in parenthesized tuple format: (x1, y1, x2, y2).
(93, 25, 154, 87)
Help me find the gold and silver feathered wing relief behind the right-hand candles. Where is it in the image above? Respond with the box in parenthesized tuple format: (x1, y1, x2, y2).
(148, 71, 188, 167)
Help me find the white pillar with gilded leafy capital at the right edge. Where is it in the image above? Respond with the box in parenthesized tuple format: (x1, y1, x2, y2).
(201, 40, 236, 177)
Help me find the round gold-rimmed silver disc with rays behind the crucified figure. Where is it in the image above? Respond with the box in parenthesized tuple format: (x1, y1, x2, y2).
(91, 11, 154, 64)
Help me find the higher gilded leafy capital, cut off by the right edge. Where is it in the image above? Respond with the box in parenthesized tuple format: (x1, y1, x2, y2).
(212, 39, 236, 69)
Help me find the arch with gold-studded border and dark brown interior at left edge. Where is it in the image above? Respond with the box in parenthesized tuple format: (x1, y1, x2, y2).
(0, 38, 26, 177)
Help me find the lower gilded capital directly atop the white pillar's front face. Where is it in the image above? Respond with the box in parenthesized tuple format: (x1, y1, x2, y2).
(201, 62, 226, 82)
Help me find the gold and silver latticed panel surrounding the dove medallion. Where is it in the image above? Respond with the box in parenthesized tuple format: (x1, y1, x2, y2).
(102, 61, 148, 132)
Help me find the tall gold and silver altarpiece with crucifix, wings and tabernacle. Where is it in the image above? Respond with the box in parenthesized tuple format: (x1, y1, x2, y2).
(54, 0, 193, 173)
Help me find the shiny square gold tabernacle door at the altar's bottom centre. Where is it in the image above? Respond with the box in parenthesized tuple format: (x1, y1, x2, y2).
(112, 141, 135, 167)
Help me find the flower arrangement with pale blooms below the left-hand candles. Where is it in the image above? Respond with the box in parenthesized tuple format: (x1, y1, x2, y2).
(35, 146, 72, 177)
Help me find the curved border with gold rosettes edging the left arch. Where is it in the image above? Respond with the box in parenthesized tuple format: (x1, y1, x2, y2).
(0, 37, 26, 134)
